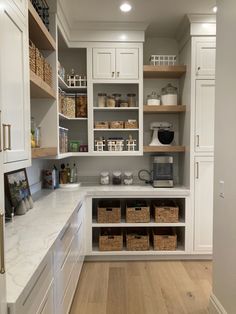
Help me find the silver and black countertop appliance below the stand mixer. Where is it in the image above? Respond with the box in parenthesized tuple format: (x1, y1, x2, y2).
(152, 155, 174, 188)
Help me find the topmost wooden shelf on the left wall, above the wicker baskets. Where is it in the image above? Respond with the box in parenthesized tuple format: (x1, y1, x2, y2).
(28, 0, 56, 50)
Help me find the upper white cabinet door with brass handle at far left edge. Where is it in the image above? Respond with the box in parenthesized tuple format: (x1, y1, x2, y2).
(0, 4, 30, 171)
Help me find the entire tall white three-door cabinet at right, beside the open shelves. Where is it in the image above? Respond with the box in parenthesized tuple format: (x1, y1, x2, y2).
(191, 37, 216, 254)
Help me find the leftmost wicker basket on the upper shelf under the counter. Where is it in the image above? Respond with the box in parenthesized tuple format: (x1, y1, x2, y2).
(97, 200, 121, 223)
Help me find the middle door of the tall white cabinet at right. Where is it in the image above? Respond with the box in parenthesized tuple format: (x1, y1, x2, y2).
(195, 80, 215, 152)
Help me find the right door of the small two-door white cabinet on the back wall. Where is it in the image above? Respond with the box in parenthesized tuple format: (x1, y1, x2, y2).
(116, 48, 139, 80)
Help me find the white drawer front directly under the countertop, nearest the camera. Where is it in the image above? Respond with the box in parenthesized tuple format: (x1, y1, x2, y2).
(17, 252, 53, 314)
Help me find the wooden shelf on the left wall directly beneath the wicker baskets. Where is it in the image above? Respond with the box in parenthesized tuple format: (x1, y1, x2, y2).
(30, 71, 57, 99)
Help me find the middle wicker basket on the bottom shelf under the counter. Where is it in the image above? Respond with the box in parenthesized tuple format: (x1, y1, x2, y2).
(126, 230, 149, 251)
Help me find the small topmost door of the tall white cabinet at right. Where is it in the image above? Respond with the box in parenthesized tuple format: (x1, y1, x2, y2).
(196, 39, 216, 78)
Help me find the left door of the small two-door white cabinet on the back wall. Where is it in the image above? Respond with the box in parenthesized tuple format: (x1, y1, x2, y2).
(93, 48, 115, 79)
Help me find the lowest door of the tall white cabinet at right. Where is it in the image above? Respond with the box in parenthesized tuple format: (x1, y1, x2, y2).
(194, 157, 214, 253)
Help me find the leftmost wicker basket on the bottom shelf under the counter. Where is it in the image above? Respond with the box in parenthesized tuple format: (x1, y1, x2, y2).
(99, 228, 123, 251)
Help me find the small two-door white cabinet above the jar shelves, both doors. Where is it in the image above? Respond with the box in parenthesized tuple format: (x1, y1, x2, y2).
(93, 48, 139, 80)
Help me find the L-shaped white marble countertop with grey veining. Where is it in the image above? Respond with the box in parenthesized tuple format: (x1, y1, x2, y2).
(5, 184, 190, 304)
